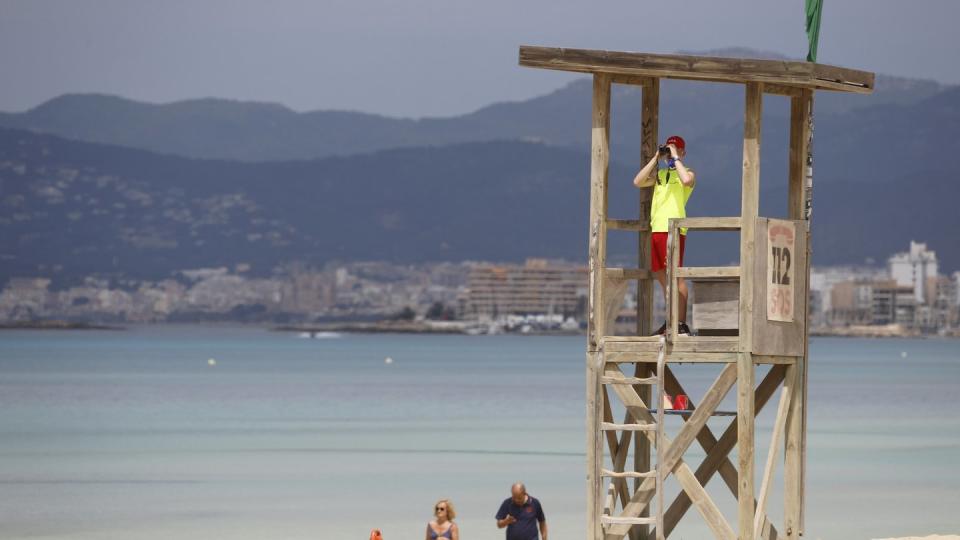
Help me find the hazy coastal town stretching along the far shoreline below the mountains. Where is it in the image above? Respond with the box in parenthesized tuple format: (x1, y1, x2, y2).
(0, 251, 960, 334)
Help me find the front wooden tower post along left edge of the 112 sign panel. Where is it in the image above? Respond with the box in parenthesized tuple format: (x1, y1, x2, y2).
(737, 83, 765, 540)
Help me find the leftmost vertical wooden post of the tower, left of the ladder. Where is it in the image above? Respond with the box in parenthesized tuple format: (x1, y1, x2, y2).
(586, 73, 610, 540)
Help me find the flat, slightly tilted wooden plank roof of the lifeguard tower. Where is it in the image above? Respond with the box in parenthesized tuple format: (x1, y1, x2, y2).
(520, 45, 874, 94)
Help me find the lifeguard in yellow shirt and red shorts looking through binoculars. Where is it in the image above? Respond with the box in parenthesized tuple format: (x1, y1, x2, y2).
(633, 135, 697, 335)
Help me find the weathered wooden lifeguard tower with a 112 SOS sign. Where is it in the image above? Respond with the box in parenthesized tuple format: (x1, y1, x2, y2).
(520, 46, 874, 540)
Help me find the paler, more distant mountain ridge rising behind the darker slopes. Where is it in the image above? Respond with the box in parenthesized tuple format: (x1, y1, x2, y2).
(0, 49, 946, 163)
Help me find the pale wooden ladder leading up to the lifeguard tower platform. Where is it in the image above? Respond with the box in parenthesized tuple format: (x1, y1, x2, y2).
(600, 336, 669, 540)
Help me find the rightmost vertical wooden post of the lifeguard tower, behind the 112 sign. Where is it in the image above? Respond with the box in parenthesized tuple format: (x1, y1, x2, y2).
(784, 89, 813, 538)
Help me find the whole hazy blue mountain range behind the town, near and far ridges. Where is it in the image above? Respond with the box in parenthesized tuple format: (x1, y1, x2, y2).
(0, 52, 960, 282)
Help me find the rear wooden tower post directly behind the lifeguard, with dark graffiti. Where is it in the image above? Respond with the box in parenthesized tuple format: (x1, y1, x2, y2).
(630, 78, 660, 540)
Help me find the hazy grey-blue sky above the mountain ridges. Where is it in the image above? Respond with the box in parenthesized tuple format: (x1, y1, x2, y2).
(0, 0, 960, 117)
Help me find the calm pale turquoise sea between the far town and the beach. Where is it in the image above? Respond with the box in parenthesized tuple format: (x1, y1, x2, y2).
(0, 326, 960, 540)
